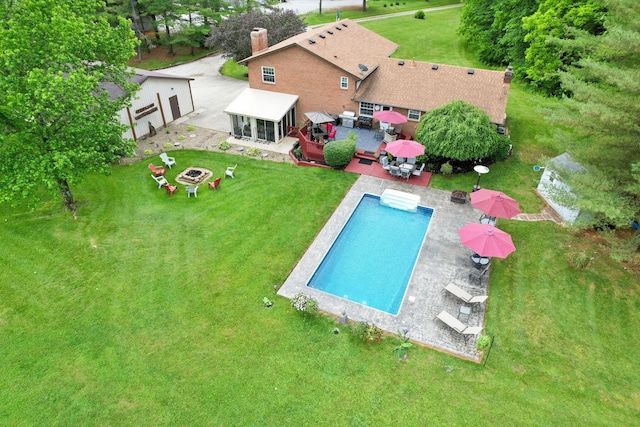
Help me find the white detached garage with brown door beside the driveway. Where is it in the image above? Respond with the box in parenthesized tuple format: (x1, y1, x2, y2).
(108, 68, 194, 140)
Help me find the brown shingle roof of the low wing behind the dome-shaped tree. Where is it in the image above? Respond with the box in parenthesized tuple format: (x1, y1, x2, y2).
(354, 58, 510, 123)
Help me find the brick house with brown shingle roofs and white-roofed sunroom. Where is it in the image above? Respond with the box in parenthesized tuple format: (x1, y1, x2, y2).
(225, 20, 513, 145)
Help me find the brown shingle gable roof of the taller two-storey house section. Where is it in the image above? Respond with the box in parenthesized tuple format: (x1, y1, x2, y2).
(240, 19, 398, 79)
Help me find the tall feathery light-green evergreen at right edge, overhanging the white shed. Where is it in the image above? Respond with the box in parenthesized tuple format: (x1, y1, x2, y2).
(549, 0, 640, 237)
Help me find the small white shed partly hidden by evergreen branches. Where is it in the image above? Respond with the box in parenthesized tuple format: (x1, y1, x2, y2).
(538, 153, 585, 223)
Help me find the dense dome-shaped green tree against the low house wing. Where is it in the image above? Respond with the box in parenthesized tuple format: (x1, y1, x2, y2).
(415, 101, 509, 161)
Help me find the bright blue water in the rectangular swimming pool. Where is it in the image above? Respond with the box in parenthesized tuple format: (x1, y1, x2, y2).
(307, 194, 433, 315)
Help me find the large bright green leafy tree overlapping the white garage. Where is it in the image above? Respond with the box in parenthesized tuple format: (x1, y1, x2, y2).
(0, 0, 136, 218)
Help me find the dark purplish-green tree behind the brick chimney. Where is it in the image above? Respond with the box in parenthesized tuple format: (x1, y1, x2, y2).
(205, 10, 306, 61)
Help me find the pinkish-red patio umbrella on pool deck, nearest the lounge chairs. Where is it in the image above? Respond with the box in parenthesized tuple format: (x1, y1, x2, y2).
(458, 223, 516, 258)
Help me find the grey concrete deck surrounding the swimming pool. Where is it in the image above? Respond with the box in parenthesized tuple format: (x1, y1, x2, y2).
(278, 175, 491, 361)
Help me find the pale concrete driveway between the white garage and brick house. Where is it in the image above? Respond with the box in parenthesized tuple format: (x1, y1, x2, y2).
(158, 55, 249, 133)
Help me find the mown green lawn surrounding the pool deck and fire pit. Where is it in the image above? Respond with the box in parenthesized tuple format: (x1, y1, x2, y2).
(5, 5, 640, 426)
